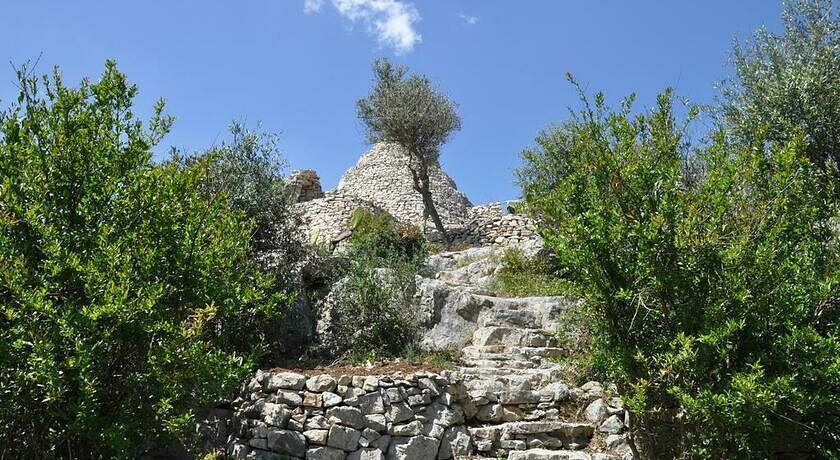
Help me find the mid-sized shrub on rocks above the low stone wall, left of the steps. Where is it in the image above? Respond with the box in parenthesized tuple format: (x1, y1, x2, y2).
(326, 208, 426, 358)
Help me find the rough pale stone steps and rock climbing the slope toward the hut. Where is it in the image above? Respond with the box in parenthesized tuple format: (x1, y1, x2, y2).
(418, 248, 632, 460)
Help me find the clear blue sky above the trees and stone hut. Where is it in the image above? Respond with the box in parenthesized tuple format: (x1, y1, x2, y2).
(0, 0, 781, 203)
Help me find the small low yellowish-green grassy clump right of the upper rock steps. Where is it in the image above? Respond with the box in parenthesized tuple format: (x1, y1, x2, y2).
(491, 248, 575, 297)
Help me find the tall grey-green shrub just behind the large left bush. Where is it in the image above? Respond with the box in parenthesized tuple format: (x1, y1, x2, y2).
(184, 122, 308, 365)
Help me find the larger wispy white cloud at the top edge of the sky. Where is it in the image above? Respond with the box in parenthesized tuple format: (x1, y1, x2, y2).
(303, 0, 422, 54)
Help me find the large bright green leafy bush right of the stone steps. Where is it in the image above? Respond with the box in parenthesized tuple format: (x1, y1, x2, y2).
(522, 77, 840, 458)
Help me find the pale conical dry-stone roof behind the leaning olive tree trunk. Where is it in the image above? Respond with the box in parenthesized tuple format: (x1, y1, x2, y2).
(337, 143, 472, 226)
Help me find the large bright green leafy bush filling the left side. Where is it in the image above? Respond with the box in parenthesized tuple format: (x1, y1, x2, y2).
(0, 62, 289, 458)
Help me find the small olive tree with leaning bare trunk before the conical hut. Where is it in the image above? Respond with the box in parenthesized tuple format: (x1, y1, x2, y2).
(356, 59, 461, 243)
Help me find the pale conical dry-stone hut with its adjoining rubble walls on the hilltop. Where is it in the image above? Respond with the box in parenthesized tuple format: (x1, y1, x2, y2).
(289, 143, 539, 246)
